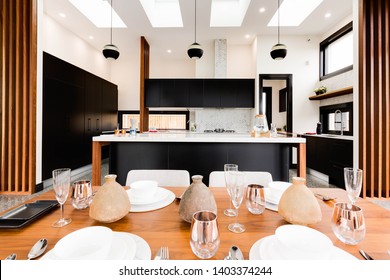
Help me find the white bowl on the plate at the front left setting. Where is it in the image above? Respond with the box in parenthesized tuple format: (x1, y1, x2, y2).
(53, 226, 113, 260)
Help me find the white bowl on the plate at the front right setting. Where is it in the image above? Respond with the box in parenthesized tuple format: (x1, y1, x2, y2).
(275, 225, 333, 260)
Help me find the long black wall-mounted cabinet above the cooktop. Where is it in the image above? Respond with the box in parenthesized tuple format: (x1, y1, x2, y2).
(145, 79, 255, 108)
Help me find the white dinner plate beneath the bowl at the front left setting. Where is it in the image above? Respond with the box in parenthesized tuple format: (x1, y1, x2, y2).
(41, 231, 152, 260)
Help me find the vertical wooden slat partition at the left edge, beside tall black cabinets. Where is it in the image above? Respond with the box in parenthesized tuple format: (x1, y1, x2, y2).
(0, 0, 37, 194)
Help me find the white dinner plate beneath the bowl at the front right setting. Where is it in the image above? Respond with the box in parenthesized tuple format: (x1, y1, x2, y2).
(249, 235, 357, 260)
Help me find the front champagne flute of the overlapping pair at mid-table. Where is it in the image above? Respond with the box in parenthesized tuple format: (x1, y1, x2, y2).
(228, 171, 246, 233)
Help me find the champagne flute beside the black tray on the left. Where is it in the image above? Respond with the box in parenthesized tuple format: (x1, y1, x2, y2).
(52, 168, 72, 227)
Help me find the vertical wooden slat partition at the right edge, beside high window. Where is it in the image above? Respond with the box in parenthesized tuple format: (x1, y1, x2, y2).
(359, 0, 390, 198)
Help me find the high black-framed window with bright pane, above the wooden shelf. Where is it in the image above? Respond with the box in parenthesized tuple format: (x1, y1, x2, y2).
(320, 22, 353, 80)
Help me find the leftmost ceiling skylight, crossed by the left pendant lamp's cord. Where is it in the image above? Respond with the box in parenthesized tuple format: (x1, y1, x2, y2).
(69, 0, 127, 28)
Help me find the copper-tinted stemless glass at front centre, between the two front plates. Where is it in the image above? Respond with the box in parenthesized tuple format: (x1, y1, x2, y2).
(190, 211, 220, 259)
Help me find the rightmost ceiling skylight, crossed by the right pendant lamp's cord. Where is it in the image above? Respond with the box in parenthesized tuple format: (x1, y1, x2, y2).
(268, 0, 323, 26)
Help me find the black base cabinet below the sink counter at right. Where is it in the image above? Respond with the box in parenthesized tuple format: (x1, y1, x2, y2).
(306, 136, 353, 188)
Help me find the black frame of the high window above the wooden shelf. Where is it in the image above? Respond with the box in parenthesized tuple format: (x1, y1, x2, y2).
(319, 22, 353, 81)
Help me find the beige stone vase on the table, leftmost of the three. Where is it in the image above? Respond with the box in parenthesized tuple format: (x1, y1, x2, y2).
(89, 174, 130, 223)
